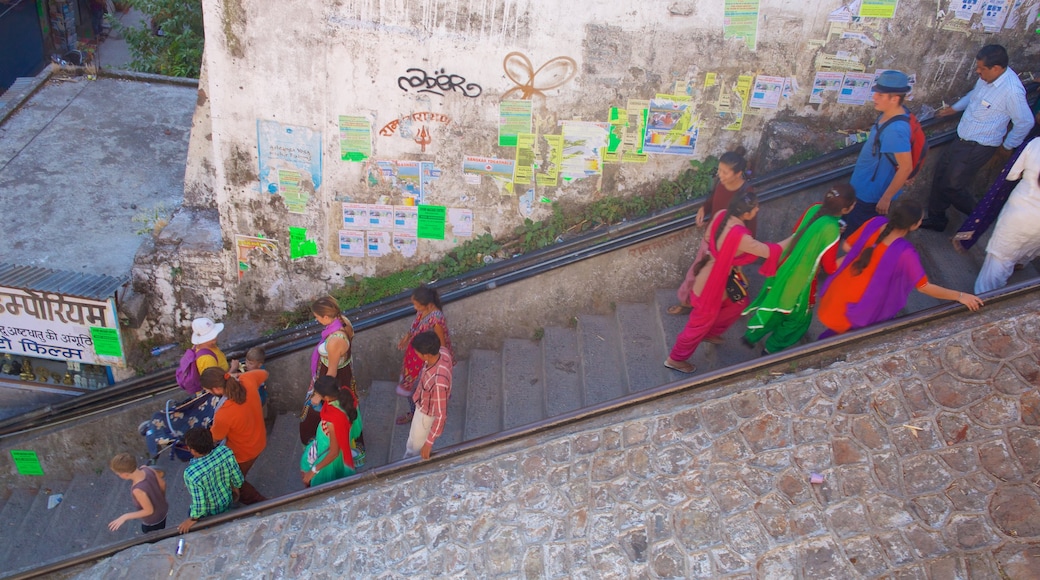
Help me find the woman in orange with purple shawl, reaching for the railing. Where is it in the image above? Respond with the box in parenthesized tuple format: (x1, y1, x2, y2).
(816, 200, 982, 339)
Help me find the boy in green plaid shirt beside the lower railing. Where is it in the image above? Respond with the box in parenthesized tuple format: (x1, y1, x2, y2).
(177, 427, 245, 533)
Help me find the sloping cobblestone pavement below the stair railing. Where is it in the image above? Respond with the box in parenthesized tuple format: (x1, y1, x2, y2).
(73, 297, 1040, 579)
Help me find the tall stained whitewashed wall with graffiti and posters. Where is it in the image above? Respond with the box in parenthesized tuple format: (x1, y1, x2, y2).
(156, 0, 1040, 330)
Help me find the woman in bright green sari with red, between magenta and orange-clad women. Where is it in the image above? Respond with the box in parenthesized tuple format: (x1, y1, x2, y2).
(744, 183, 856, 354)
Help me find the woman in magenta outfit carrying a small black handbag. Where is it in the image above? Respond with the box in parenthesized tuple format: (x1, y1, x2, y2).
(665, 192, 789, 373)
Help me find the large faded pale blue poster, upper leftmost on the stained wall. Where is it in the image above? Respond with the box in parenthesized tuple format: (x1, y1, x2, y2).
(257, 120, 321, 213)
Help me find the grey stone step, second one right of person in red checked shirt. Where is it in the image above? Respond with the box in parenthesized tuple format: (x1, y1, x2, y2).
(463, 349, 502, 441)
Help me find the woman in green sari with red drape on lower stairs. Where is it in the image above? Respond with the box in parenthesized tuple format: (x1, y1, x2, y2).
(300, 376, 361, 486)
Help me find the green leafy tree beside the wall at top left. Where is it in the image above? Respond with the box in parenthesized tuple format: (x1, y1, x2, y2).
(109, 0, 204, 79)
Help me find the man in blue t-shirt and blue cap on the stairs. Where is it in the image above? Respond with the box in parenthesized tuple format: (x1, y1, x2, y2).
(844, 71, 913, 236)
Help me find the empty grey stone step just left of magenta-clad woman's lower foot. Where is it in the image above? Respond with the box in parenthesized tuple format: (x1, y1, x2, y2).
(615, 304, 671, 393)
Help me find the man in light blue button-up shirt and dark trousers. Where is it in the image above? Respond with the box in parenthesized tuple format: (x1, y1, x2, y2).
(920, 45, 1034, 232)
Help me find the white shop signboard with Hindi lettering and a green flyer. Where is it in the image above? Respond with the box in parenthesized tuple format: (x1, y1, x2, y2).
(0, 286, 126, 367)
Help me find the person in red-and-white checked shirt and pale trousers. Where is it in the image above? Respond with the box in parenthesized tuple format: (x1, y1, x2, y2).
(405, 331, 452, 459)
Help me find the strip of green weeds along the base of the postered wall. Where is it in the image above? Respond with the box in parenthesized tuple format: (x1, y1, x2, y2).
(280, 157, 719, 328)
